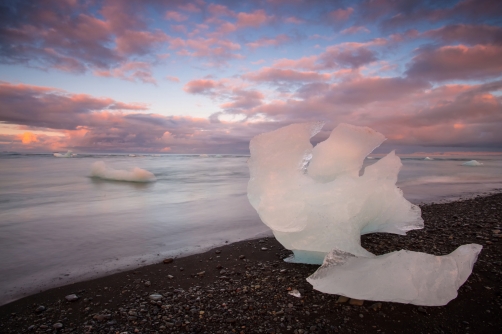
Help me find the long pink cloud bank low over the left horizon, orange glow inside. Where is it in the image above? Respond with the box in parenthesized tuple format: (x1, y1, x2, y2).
(0, 83, 270, 153)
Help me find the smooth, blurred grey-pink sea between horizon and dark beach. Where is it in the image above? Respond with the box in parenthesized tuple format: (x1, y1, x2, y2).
(0, 153, 502, 305)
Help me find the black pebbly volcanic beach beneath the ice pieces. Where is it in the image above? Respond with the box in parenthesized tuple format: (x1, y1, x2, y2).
(0, 194, 502, 333)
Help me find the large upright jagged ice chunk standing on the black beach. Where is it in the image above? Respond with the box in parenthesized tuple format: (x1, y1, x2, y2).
(248, 123, 423, 264)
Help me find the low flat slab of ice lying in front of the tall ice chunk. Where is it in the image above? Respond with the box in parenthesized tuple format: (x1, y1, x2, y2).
(307, 244, 482, 306)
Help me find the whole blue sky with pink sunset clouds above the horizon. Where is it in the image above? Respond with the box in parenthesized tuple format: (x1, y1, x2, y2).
(0, 0, 502, 154)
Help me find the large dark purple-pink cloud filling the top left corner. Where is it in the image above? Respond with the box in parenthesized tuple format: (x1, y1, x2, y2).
(0, 0, 169, 81)
